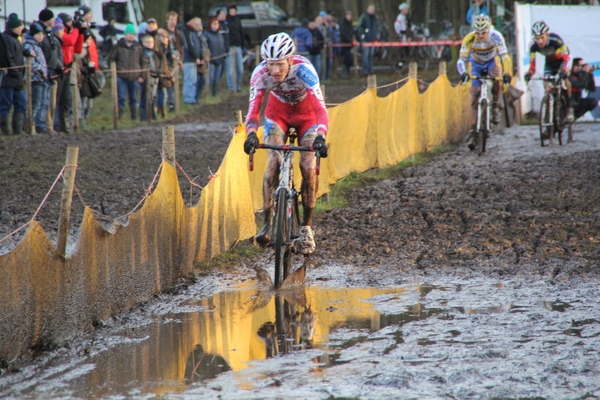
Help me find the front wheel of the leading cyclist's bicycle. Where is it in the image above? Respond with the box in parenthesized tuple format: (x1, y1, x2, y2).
(274, 189, 294, 288)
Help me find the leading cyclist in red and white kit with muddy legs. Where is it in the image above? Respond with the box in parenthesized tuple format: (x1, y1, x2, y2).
(244, 33, 329, 254)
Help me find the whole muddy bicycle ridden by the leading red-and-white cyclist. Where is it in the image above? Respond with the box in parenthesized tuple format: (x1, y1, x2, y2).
(249, 128, 321, 288)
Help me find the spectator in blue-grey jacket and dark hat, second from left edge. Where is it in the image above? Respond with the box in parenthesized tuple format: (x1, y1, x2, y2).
(23, 22, 48, 134)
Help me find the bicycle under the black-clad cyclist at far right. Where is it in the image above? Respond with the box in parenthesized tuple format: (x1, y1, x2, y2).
(532, 74, 573, 147)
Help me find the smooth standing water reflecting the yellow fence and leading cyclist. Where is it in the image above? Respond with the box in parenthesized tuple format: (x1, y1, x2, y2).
(19, 285, 576, 397)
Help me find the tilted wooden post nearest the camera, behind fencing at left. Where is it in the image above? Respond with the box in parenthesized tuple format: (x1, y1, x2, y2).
(56, 146, 79, 258)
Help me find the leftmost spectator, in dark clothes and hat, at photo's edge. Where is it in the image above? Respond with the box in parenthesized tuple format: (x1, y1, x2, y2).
(0, 13, 27, 135)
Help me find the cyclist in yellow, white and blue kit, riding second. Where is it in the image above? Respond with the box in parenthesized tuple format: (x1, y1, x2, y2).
(456, 14, 512, 150)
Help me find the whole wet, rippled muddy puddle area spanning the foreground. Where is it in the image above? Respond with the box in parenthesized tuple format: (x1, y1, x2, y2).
(0, 280, 600, 399)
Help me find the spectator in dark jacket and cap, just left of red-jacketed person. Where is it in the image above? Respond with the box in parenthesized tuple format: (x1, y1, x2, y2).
(35, 8, 64, 135)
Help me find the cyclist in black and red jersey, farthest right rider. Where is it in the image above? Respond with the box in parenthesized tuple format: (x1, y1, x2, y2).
(525, 21, 573, 122)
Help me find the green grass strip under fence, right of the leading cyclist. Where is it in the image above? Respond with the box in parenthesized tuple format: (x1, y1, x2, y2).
(315, 144, 456, 213)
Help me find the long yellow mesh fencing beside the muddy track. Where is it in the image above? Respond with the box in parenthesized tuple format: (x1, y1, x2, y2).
(0, 76, 468, 360)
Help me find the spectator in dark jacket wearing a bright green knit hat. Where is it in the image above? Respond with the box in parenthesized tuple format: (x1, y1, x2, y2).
(109, 24, 148, 121)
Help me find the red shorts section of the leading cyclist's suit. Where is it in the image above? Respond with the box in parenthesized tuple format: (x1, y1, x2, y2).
(265, 96, 318, 144)
